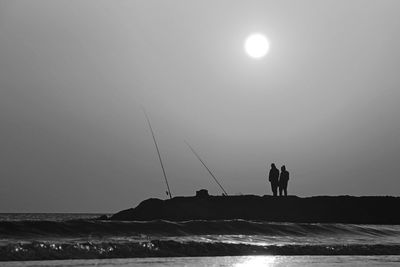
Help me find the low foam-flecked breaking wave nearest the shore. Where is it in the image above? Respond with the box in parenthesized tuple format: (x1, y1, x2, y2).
(0, 240, 400, 261)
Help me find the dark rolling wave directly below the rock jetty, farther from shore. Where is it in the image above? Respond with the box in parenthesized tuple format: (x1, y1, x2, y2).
(0, 220, 400, 239)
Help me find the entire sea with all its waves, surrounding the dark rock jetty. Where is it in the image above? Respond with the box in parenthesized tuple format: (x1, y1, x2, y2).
(0, 213, 400, 267)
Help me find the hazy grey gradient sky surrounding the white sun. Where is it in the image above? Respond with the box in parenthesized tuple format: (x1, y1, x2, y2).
(0, 0, 400, 213)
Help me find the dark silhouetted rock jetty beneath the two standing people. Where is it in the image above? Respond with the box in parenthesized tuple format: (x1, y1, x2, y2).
(110, 194, 400, 224)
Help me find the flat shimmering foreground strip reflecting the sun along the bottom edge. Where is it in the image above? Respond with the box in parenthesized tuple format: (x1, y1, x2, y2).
(2, 256, 400, 267)
